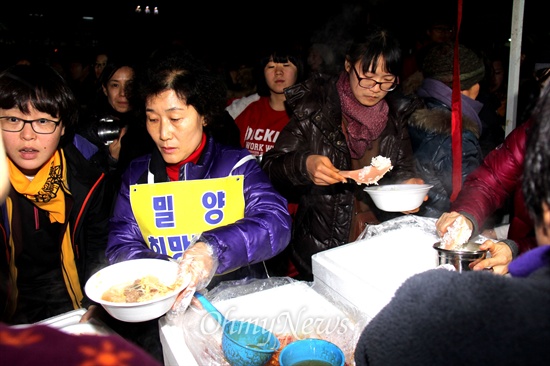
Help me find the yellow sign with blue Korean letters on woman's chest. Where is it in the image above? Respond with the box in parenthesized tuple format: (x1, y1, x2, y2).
(130, 175, 244, 259)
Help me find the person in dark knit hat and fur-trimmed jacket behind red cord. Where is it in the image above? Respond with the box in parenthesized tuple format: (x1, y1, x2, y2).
(408, 42, 485, 218)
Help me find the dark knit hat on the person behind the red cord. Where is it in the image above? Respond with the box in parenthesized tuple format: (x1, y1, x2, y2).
(422, 42, 485, 90)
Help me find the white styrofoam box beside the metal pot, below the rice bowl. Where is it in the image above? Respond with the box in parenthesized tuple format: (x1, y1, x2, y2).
(312, 220, 438, 319)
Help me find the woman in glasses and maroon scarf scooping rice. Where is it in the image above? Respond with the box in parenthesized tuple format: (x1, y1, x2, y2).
(262, 28, 423, 280)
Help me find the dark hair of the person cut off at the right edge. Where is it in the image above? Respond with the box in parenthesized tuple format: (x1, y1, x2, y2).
(523, 84, 550, 223)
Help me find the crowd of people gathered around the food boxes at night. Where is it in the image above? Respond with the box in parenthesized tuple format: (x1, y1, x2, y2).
(0, 14, 550, 365)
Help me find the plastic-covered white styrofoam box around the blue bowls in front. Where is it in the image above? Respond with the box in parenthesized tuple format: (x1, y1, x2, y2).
(159, 281, 366, 365)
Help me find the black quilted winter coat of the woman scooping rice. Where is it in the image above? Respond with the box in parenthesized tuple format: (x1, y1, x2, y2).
(262, 74, 416, 280)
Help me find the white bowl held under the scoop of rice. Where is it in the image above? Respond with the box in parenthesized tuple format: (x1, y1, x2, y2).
(364, 184, 433, 212)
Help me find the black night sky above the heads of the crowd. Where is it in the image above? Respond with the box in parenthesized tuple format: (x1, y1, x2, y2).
(0, 0, 550, 69)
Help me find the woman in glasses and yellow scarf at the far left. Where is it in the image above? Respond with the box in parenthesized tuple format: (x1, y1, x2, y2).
(0, 63, 113, 324)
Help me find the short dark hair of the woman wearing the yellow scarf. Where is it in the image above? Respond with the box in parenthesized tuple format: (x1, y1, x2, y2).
(0, 63, 79, 145)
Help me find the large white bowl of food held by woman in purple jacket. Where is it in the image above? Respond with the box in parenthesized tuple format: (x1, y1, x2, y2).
(84, 259, 187, 323)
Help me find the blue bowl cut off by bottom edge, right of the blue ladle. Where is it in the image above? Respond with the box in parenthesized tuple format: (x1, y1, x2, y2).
(279, 338, 346, 366)
